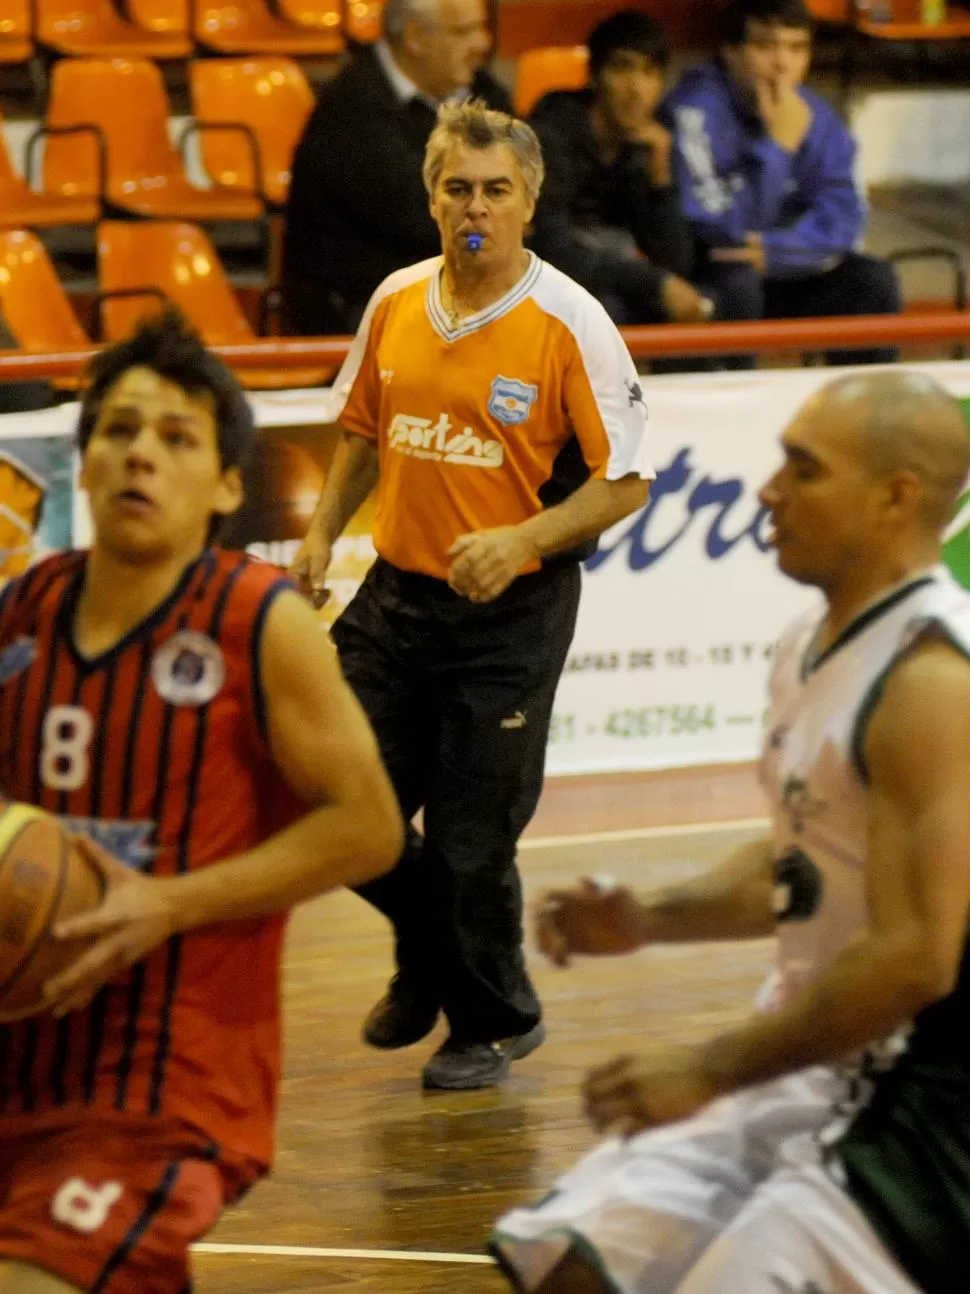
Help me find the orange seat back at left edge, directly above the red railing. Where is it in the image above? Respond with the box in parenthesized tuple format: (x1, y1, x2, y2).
(0, 229, 91, 351)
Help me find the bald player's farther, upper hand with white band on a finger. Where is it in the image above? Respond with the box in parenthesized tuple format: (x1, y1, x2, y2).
(534, 879, 643, 967)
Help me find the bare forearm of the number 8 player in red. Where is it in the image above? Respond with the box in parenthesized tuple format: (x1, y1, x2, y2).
(159, 802, 404, 933)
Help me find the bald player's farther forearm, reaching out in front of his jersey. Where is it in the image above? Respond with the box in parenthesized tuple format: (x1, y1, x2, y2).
(639, 839, 775, 945)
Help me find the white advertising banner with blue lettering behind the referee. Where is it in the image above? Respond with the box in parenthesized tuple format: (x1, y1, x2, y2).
(7, 364, 970, 774)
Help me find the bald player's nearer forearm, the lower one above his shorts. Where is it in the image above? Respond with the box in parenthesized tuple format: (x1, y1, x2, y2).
(701, 938, 947, 1093)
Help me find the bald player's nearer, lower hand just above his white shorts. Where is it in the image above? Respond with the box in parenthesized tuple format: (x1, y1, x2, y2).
(583, 1043, 720, 1136)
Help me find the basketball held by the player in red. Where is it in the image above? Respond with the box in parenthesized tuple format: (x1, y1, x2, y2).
(0, 804, 103, 1021)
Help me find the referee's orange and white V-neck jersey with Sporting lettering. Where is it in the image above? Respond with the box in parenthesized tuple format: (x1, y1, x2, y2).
(335, 252, 653, 580)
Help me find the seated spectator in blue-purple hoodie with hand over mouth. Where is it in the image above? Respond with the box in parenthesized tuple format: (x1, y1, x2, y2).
(661, 0, 900, 364)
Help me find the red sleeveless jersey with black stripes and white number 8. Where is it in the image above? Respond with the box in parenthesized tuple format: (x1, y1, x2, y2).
(0, 549, 300, 1165)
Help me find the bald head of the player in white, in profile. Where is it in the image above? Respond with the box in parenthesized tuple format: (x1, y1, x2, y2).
(762, 370, 970, 589)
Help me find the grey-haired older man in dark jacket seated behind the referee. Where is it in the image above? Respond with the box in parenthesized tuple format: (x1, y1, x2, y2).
(283, 0, 511, 336)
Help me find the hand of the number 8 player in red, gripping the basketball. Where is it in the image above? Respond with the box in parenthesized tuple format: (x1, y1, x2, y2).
(44, 836, 177, 1016)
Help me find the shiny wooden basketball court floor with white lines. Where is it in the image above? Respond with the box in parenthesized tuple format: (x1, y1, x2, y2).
(195, 767, 771, 1294)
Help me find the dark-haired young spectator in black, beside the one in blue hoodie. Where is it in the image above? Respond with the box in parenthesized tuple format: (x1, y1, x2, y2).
(530, 9, 713, 324)
